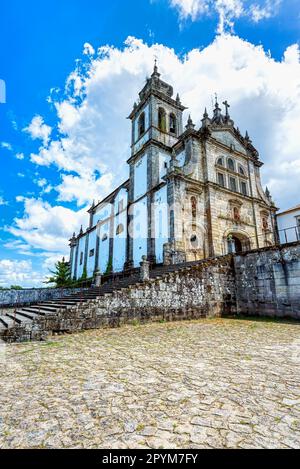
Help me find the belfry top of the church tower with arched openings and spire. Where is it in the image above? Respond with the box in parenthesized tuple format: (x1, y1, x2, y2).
(128, 60, 186, 156)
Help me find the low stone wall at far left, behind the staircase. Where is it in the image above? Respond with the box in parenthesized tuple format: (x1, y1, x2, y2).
(0, 288, 85, 310)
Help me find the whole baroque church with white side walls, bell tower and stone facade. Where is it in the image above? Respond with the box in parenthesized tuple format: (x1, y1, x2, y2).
(70, 65, 276, 279)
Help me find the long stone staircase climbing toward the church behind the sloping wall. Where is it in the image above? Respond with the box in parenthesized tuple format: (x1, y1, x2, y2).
(0, 259, 225, 341)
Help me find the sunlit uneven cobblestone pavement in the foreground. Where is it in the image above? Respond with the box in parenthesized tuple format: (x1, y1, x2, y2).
(0, 319, 300, 448)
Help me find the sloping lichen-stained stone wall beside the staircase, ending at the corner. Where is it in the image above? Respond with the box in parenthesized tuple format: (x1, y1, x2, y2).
(5, 256, 235, 341)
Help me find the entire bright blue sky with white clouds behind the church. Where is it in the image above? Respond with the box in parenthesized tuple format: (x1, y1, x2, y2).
(0, 0, 300, 286)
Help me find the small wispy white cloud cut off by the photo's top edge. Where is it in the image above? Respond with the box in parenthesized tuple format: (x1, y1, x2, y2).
(169, 0, 282, 34)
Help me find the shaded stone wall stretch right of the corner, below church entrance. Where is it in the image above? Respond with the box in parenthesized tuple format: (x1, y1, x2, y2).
(234, 243, 300, 319)
